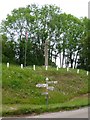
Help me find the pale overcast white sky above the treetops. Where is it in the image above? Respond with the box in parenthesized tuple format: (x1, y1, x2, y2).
(0, 0, 90, 22)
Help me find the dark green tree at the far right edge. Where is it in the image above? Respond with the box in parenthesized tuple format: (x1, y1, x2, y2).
(78, 17, 90, 71)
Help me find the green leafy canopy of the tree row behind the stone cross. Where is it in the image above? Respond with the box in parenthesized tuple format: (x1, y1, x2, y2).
(1, 4, 89, 70)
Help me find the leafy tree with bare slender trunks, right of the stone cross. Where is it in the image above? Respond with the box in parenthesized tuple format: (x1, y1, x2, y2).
(55, 13, 83, 68)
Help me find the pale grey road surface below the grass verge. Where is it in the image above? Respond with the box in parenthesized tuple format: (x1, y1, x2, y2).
(26, 108, 88, 118)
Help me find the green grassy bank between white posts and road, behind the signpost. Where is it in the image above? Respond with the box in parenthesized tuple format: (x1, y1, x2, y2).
(2, 65, 88, 115)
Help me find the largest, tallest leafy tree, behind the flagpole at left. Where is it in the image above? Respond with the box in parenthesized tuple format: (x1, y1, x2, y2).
(2, 5, 62, 65)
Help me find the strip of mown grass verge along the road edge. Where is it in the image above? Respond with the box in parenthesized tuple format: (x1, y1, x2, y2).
(3, 96, 88, 116)
